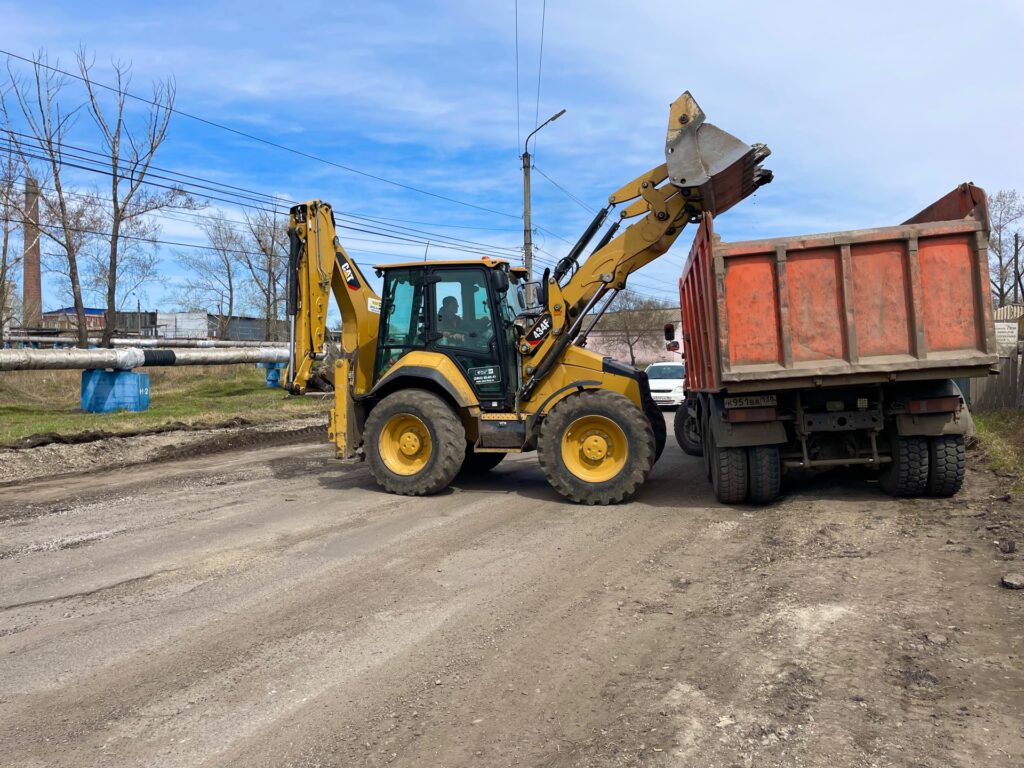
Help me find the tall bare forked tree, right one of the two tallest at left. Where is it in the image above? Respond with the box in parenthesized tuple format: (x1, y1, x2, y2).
(78, 48, 196, 346)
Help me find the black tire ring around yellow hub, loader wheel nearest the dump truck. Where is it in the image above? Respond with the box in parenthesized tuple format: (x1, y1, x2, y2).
(537, 389, 654, 504)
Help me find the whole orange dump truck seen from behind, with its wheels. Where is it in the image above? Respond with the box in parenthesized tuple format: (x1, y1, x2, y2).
(666, 183, 997, 504)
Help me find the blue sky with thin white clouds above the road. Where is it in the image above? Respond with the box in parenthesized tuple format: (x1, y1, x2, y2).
(0, 0, 1024, 313)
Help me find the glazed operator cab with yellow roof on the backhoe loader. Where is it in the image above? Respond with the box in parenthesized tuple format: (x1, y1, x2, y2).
(373, 258, 526, 411)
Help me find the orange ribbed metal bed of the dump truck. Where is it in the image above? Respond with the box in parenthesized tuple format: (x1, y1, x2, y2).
(679, 184, 996, 392)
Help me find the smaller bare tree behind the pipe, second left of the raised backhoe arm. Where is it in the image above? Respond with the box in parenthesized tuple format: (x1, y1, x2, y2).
(177, 219, 245, 339)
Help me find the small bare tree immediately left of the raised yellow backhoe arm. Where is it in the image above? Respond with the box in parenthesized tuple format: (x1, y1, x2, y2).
(240, 210, 288, 341)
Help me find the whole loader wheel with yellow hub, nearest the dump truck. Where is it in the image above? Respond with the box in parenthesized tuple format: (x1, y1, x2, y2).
(537, 390, 654, 504)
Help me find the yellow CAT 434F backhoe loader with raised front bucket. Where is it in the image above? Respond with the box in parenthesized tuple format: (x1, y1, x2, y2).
(283, 92, 771, 504)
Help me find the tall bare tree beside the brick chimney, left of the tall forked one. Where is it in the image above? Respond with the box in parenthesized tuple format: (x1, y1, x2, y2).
(0, 53, 96, 347)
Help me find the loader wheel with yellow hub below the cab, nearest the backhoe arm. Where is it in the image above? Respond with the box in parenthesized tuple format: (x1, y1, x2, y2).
(364, 389, 466, 496)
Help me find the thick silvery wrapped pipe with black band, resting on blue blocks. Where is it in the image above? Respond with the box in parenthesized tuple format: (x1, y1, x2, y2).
(0, 347, 288, 371)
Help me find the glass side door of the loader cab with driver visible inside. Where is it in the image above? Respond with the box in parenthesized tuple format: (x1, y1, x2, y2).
(427, 266, 511, 410)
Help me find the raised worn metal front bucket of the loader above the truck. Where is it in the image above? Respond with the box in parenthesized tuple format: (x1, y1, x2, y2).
(665, 91, 772, 216)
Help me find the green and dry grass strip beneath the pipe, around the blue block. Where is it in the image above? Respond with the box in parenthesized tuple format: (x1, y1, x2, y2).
(0, 365, 329, 444)
